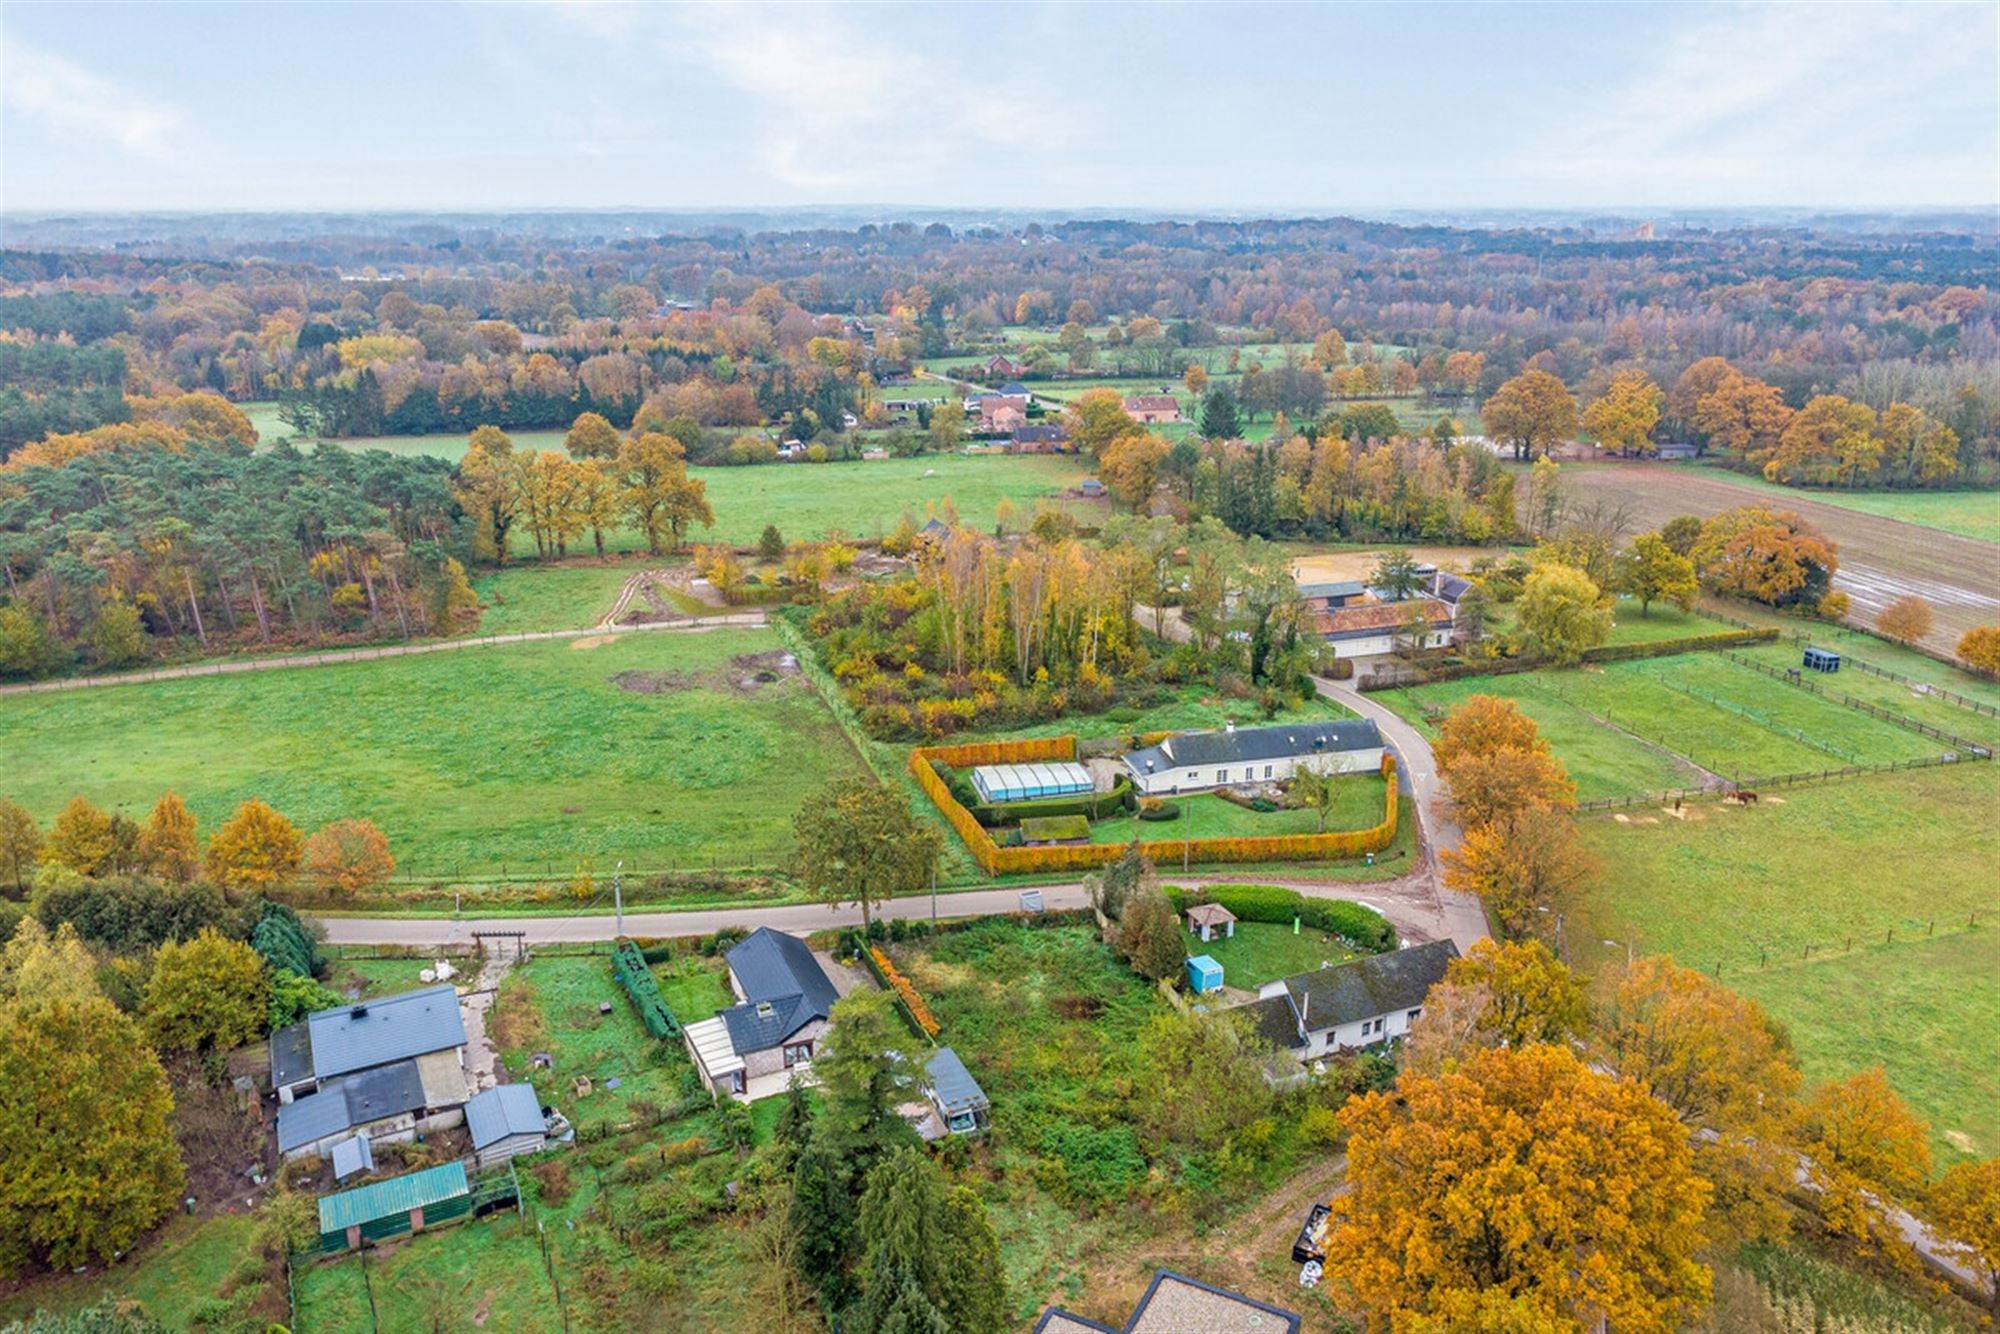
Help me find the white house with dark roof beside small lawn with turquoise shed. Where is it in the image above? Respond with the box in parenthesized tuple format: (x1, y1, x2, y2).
(1242, 940, 1458, 1060)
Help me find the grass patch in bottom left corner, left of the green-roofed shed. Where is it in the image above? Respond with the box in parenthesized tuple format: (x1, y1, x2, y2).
(0, 1214, 270, 1330)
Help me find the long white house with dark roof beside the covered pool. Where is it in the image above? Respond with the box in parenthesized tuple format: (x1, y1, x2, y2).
(1124, 718, 1382, 796)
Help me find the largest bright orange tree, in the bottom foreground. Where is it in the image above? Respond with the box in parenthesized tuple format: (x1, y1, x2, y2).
(1326, 1046, 1710, 1334)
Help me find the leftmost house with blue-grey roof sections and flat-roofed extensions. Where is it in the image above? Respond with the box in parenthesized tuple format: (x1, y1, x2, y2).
(270, 986, 468, 1158)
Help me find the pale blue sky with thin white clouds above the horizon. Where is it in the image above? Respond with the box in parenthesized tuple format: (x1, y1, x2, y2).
(0, 0, 2000, 214)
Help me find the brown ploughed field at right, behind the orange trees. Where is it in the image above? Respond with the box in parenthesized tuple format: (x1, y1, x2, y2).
(1564, 464, 2000, 652)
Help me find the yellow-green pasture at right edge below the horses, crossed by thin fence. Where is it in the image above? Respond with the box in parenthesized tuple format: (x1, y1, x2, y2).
(1570, 764, 2000, 1154)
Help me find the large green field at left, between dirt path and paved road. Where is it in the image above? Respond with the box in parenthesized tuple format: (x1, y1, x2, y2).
(0, 630, 860, 880)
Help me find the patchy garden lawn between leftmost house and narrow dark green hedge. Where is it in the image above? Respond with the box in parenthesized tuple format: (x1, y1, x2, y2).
(494, 954, 706, 1128)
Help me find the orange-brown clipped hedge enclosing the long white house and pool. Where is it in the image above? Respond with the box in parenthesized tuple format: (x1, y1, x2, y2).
(910, 736, 1398, 876)
